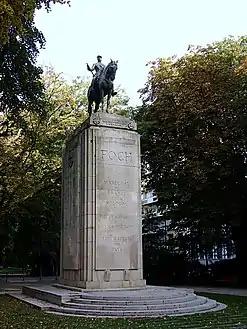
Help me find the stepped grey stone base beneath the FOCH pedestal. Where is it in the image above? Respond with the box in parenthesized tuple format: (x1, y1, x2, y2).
(12, 286, 226, 317)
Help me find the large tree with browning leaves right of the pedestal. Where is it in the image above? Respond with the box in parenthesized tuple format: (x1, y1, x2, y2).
(137, 37, 247, 279)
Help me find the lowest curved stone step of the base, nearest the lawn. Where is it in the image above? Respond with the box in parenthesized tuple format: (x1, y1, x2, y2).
(50, 299, 217, 317)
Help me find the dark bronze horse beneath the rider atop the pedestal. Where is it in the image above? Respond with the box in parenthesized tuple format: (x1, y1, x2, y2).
(87, 60, 118, 116)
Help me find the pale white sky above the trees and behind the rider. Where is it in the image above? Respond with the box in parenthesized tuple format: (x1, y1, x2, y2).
(36, 0, 247, 105)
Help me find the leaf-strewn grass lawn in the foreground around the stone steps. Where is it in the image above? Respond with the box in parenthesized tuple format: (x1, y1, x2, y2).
(0, 294, 247, 329)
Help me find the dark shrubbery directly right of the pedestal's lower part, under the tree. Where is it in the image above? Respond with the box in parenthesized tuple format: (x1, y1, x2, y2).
(142, 210, 192, 285)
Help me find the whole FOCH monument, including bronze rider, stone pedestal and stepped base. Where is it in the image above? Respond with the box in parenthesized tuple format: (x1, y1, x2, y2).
(15, 56, 225, 317)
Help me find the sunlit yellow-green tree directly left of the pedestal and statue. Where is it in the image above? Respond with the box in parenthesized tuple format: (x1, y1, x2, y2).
(0, 69, 87, 266)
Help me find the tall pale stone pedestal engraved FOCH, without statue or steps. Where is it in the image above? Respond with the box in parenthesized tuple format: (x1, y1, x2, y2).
(60, 113, 145, 289)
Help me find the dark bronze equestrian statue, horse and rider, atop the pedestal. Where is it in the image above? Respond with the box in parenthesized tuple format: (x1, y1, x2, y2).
(87, 56, 118, 116)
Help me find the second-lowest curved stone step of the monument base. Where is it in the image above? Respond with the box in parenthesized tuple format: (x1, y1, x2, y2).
(63, 297, 207, 311)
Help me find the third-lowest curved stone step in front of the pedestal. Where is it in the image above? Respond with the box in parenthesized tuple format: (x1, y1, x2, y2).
(71, 294, 198, 306)
